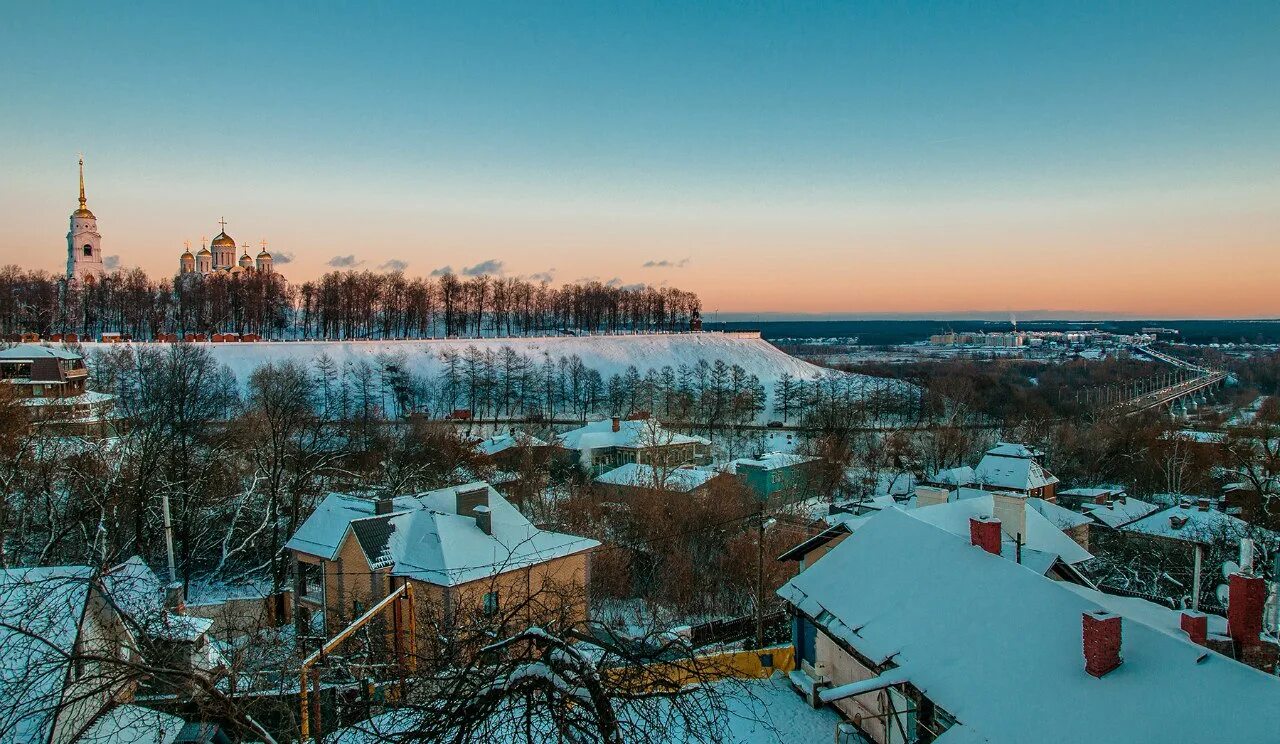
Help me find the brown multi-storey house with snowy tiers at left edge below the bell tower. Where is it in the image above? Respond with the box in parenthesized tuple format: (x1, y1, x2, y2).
(0, 343, 115, 420)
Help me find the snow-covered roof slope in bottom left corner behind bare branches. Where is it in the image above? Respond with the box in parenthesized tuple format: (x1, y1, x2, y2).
(0, 566, 93, 744)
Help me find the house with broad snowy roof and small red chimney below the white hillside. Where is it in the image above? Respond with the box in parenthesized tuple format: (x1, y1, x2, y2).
(556, 416, 710, 474)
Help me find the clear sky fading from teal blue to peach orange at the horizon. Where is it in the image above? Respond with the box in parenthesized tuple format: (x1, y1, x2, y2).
(0, 0, 1280, 318)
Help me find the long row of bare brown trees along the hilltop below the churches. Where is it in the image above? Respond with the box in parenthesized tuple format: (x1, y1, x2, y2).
(0, 265, 701, 339)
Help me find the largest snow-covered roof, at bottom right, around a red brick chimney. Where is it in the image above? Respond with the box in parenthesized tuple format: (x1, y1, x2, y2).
(778, 510, 1280, 744)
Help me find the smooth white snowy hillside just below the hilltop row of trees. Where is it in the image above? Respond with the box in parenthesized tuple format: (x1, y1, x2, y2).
(84, 333, 860, 417)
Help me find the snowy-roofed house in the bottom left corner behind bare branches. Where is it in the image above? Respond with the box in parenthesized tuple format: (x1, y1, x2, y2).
(0, 566, 141, 744)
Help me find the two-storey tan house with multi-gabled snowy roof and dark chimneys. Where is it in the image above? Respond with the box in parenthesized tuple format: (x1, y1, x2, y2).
(285, 481, 599, 651)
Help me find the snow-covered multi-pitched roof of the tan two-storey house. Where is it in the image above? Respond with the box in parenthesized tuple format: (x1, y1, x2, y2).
(284, 481, 600, 586)
